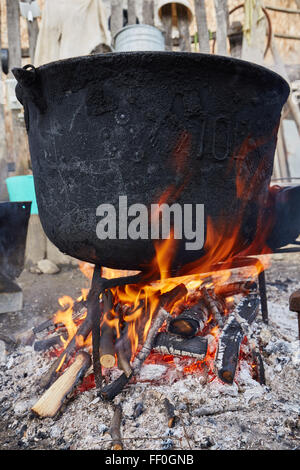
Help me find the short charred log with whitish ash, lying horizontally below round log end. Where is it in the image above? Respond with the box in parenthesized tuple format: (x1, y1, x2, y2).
(153, 332, 207, 360)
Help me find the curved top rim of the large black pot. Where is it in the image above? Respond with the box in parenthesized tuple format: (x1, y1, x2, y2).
(36, 51, 290, 95)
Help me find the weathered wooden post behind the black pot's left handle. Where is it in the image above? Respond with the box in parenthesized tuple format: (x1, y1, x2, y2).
(6, 0, 30, 175)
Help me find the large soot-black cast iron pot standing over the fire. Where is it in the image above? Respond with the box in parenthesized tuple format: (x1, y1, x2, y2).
(13, 52, 289, 269)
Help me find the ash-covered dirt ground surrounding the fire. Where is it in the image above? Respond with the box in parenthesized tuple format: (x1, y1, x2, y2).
(0, 254, 300, 450)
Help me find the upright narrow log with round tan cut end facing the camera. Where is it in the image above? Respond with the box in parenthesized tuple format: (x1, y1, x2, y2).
(100, 290, 116, 369)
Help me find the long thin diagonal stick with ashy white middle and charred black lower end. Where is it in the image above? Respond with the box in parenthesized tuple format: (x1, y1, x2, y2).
(100, 284, 187, 400)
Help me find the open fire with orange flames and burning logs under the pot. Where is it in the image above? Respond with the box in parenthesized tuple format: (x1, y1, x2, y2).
(32, 233, 264, 416)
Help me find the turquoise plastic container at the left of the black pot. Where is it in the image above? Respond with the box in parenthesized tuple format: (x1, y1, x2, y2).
(6, 175, 38, 214)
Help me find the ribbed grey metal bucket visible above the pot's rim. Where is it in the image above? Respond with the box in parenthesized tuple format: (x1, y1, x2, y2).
(112, 24, 165, 52)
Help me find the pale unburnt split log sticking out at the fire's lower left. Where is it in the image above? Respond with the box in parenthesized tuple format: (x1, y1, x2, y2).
(32, 351, 91, 418)
